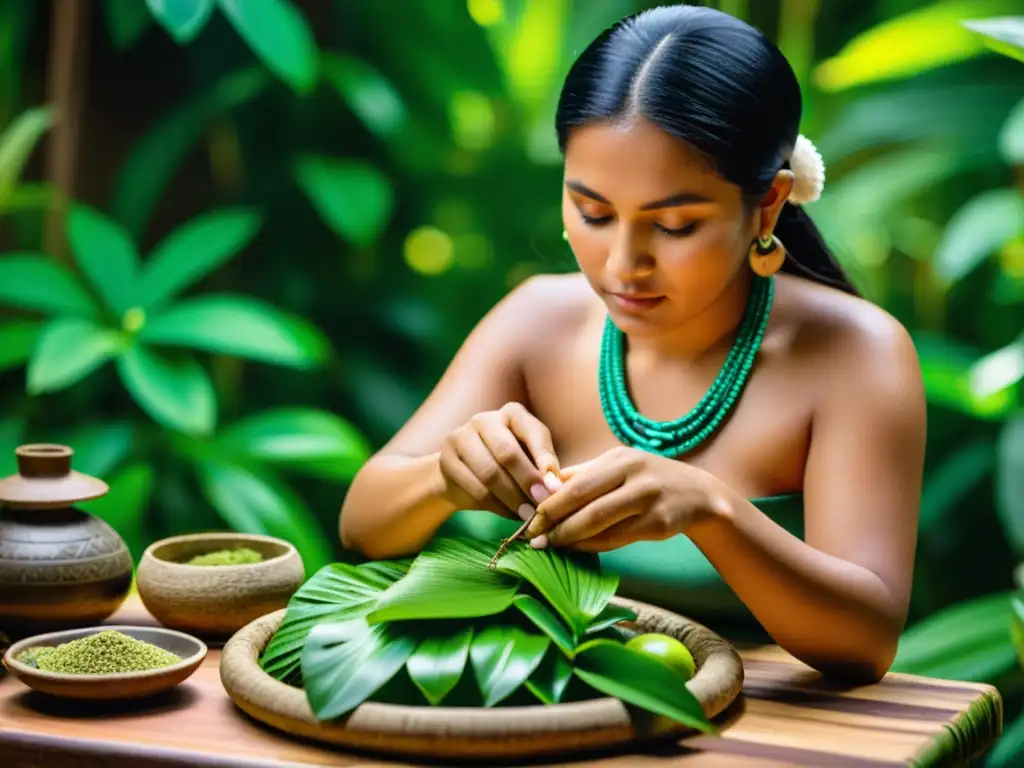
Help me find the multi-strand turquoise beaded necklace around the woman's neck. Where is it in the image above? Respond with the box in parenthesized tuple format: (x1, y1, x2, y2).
(598, 275, 774, 459)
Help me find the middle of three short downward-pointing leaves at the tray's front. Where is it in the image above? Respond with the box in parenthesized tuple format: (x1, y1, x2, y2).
(471, 626, 551, 707)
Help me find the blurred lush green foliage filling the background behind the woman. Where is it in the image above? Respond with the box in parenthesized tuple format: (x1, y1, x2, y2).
(0, 0, 1024, 765)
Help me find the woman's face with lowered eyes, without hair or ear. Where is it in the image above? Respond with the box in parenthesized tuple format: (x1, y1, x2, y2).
(562, 119, 760, 335)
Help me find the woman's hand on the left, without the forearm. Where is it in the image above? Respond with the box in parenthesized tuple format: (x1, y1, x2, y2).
(439, 402, 560, 520)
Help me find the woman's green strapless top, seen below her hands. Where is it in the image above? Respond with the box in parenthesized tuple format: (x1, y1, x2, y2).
(439, 494, 804, 642)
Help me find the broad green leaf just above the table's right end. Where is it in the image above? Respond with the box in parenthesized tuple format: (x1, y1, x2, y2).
(892, 592, 1017, 682)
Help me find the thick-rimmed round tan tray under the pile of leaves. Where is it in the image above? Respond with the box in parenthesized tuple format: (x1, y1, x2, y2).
(220, 597, 743, 760)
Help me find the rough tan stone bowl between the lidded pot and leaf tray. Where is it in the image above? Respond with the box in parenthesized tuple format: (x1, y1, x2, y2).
(135, 534, 305, 640)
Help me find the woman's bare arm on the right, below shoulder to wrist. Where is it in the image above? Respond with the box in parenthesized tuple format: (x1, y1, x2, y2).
(687, 315, 926, 680)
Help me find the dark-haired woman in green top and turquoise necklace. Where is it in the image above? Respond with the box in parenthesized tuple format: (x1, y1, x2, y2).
(341, 5, 925, 680)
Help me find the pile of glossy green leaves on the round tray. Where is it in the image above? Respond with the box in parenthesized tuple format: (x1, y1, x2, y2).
(260, 538, 716, 732)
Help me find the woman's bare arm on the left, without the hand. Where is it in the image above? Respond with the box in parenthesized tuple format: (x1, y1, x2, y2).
(339, 279, 543, 559)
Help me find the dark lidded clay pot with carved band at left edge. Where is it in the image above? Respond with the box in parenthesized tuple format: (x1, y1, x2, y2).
(0, 444, 132, 637)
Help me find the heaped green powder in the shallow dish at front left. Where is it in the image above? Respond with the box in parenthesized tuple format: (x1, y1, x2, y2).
(17, 630, 181, 675)
